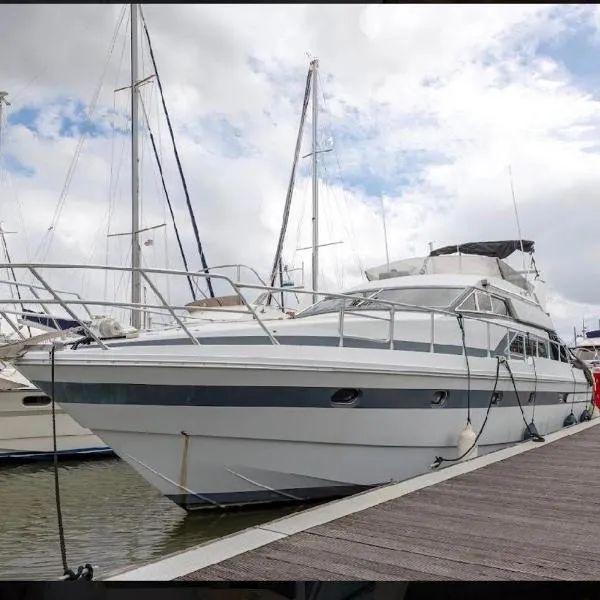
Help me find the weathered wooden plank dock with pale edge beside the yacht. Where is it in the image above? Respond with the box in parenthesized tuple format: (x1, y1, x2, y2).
(105, 419, 600, 581)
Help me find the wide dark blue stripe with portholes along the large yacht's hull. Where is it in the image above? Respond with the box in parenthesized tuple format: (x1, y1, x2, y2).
(34, 381, 584, 409)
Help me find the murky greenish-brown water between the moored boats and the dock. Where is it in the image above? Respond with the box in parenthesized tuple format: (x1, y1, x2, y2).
(0, 459, 308, 579)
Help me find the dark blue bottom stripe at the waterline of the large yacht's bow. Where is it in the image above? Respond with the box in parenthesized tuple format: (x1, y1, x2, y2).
(166, 485, 376, 511)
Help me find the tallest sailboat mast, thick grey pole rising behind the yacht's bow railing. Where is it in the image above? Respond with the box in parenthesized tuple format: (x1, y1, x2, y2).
(131, 4, 142, 329)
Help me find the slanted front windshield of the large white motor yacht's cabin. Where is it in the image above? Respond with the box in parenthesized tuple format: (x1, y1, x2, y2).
(296, 287, 464, 317)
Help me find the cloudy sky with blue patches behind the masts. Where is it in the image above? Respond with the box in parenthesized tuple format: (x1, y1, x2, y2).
(0, 4, 600, 340)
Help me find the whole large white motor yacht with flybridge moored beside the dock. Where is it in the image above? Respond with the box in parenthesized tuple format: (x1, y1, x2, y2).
(4, 241, 592, 510)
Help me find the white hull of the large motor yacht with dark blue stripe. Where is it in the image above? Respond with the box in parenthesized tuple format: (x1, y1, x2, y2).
(19, 346, 590, 510)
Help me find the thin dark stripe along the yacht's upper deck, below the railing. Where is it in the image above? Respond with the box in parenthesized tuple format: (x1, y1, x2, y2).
(97, 335, 506, 357)
